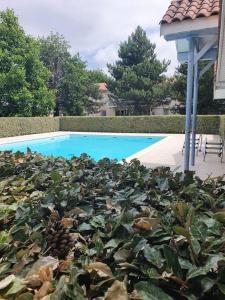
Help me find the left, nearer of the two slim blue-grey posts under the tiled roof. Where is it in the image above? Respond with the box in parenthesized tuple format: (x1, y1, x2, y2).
(184, 38, 195, 172)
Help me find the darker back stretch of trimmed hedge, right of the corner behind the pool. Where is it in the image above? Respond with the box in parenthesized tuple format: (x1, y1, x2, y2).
(60, 115, 220, 134)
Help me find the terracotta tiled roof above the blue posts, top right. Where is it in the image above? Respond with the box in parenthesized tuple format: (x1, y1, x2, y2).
(161, 0, 220, 24)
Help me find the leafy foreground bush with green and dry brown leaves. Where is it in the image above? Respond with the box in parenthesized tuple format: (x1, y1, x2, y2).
(0, 152, 225, 300)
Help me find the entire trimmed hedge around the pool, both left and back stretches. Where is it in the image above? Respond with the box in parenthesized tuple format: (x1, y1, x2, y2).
(0, 115, 225, 137)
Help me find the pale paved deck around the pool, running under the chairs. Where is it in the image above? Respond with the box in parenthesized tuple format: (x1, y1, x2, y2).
(0, 131, 225, 179)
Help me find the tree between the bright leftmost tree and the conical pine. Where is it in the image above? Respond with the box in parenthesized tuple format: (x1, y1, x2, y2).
(39, 33, 100, 116)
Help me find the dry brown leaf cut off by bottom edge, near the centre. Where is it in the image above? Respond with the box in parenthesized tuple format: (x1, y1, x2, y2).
(105, 280, 128, 300)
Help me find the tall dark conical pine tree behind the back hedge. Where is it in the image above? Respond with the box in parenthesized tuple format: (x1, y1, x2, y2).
(108, 26, 169, 115)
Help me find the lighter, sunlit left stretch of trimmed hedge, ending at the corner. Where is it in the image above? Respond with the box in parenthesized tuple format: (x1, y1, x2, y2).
(0, 117, 60, 137)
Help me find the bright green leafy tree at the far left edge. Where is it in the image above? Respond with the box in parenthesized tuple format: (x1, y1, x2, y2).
(0, 9, 54, 116)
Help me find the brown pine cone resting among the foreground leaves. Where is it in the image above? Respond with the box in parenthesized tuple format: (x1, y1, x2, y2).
(46, 221, 74, 259)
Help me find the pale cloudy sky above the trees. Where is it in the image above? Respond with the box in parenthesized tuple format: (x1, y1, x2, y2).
(0, 0, 177, 76)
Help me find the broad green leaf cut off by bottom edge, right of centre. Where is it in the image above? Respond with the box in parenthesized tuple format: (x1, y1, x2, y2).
(135, 281, 173, 300)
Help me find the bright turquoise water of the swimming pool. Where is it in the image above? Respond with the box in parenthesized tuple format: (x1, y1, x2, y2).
(0, 134, 163, 160)
